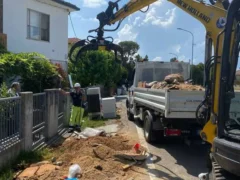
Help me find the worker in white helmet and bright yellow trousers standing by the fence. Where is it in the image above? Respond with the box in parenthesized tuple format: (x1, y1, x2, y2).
(69, 83, 84, 132)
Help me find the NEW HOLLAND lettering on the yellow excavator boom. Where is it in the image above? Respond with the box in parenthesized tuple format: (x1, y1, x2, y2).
(177, 0, 211, 23)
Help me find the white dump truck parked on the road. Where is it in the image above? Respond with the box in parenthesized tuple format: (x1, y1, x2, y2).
(126, 62, 240, 142)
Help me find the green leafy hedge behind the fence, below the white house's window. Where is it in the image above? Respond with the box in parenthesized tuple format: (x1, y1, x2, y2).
(0, 53, 62, 93)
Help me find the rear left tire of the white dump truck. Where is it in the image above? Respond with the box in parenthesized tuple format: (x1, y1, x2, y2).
(143, 111, 155, 143)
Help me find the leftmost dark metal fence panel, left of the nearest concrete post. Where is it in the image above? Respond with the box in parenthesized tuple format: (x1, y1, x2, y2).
(0, 97, 21, 153)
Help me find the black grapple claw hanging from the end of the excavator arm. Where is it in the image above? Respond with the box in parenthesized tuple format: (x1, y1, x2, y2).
(69, 0, 123, 63)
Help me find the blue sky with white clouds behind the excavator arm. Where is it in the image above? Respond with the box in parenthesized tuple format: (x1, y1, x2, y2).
(66, 0, 218, 64)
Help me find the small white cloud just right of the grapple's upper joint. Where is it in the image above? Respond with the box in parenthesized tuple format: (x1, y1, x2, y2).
(114, 24, 138, 43)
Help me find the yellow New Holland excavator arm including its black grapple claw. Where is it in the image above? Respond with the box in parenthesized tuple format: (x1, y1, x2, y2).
(69, 0, 229, 144)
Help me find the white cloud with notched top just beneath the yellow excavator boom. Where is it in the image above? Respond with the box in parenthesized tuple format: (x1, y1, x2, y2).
(142, 7, 176, 27)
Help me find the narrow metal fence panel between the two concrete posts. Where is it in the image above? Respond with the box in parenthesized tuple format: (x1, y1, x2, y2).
(32, 93, 46, 148)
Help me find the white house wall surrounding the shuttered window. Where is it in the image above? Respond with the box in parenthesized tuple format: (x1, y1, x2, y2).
(3, 0, 68, 61)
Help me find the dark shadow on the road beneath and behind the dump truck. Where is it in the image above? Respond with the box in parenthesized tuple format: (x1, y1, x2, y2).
(129, 116, 209, 180)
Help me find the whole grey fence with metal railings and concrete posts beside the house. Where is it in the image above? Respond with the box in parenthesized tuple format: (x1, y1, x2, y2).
(0, 89, 70, 168)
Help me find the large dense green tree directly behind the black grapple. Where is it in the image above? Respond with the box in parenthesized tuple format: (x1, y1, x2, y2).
(69, 51, 126, 87)
